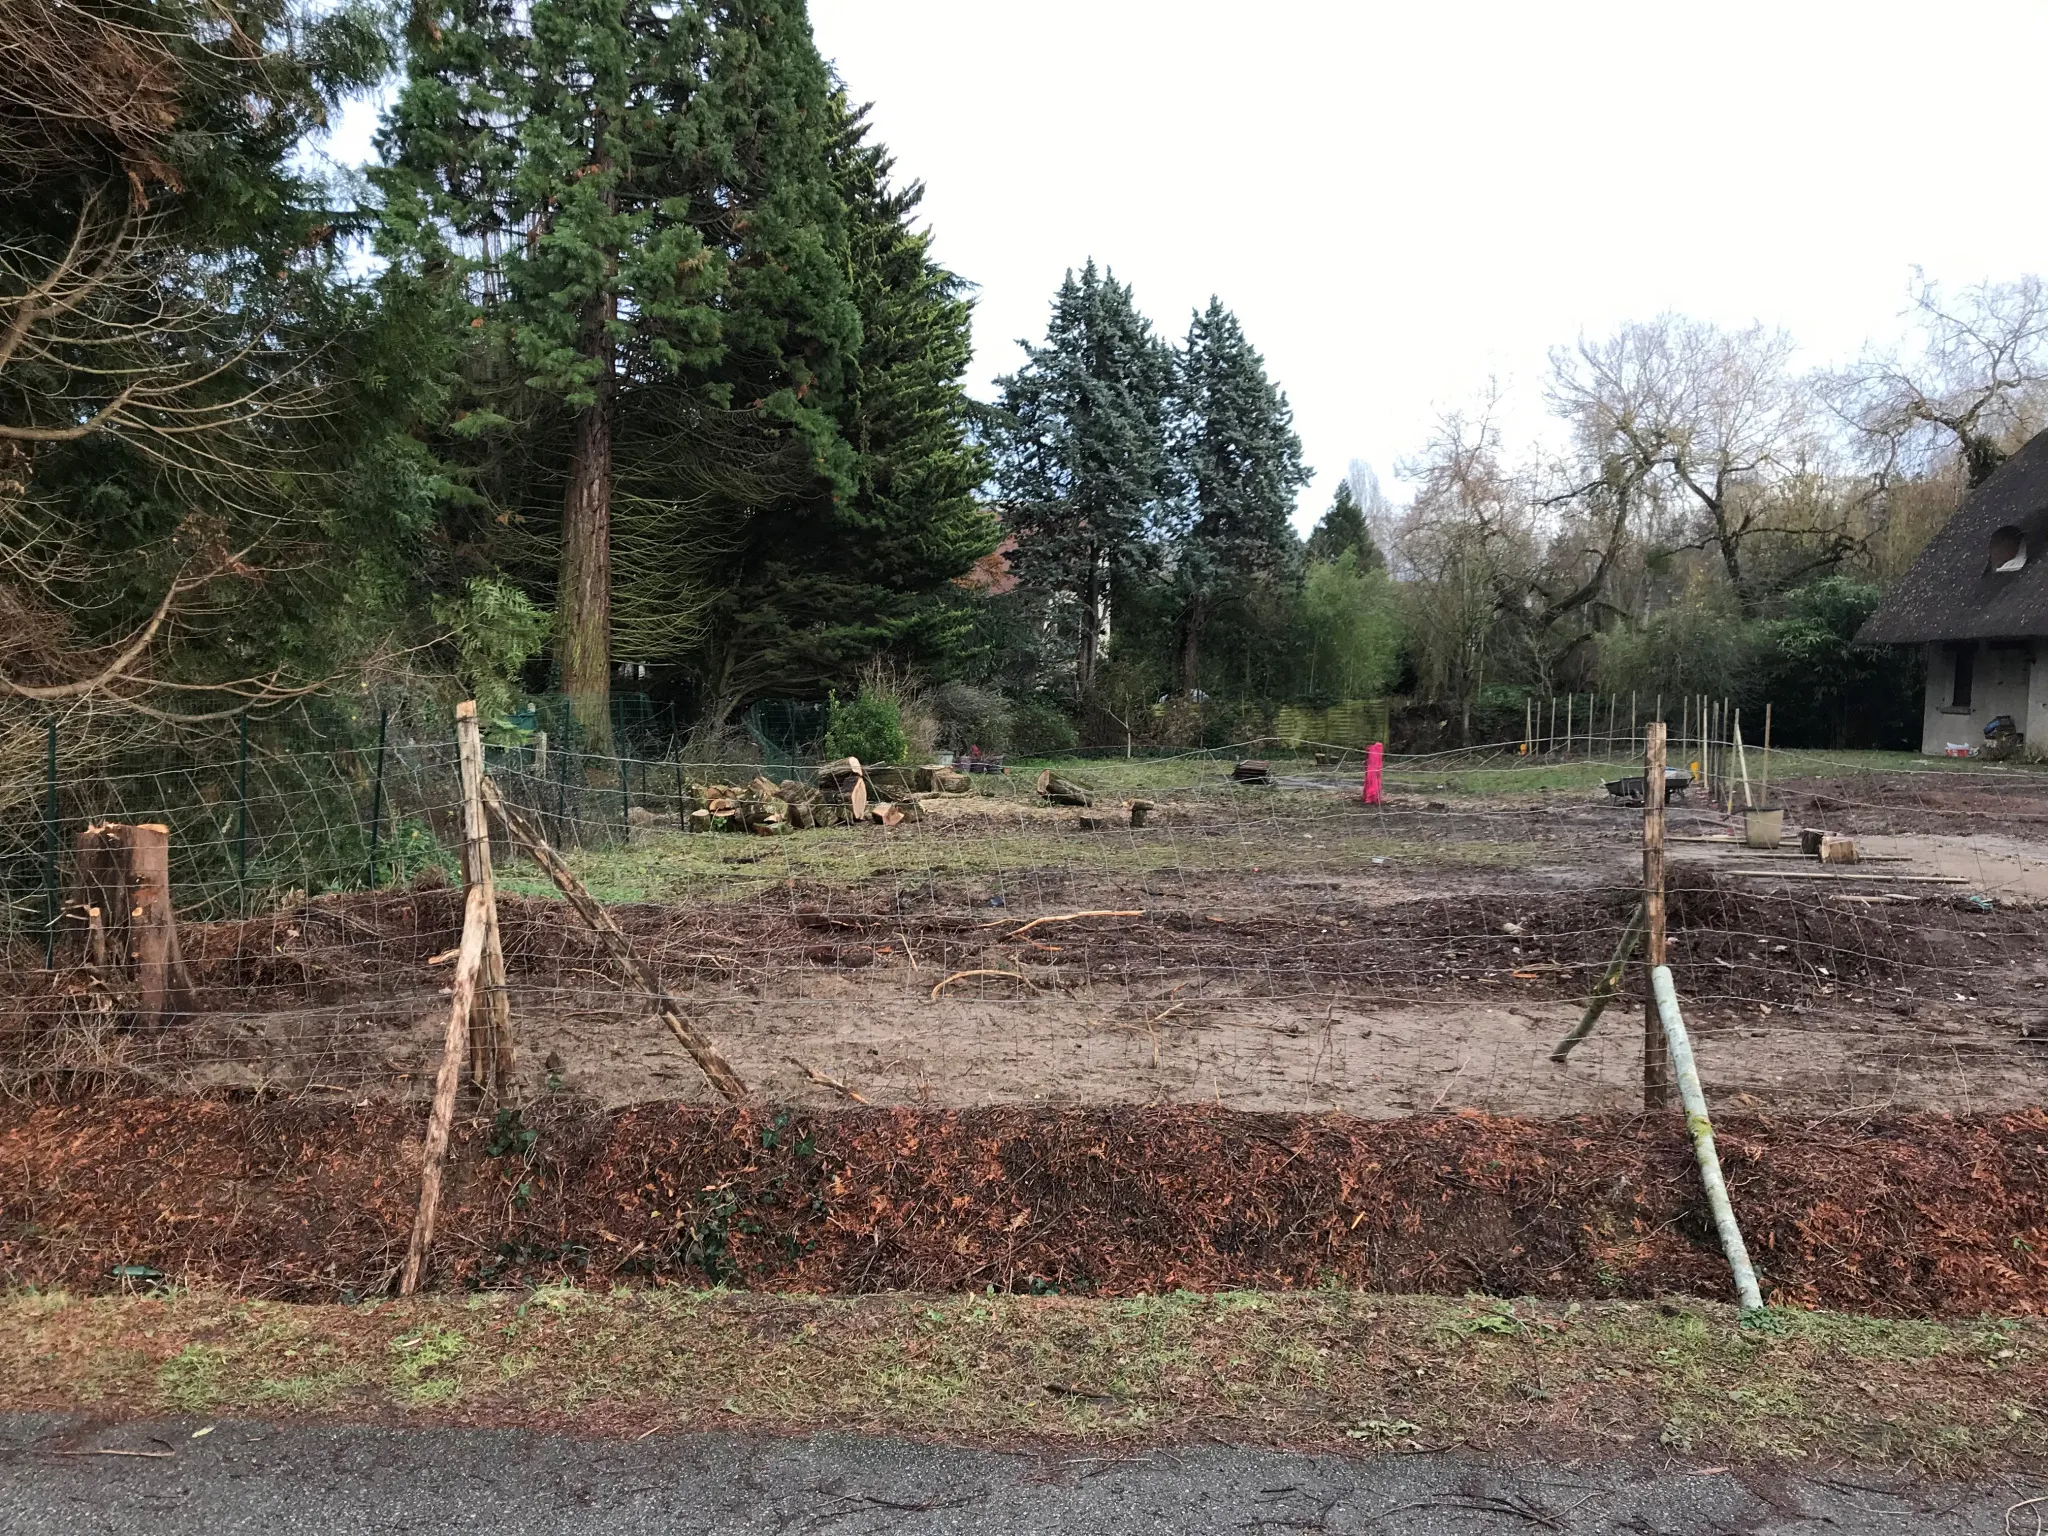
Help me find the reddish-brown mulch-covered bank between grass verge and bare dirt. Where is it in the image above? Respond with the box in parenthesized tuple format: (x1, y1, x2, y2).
(0, 1100, 2048, 1317)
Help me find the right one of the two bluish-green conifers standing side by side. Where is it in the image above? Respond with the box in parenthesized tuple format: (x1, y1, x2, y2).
(1171, 297, 1309, 690)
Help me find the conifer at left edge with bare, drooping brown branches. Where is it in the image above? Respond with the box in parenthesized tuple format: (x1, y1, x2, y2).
(0, 0, 430, 733)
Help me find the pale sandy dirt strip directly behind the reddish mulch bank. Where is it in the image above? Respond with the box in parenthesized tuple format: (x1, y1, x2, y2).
(172, 977, 2048, 1116)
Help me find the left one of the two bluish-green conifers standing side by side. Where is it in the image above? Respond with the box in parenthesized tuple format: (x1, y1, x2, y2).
(995, 260, 1174, 694)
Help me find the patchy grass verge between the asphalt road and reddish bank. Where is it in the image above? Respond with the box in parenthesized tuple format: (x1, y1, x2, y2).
(0, 1288, 2048, 1473)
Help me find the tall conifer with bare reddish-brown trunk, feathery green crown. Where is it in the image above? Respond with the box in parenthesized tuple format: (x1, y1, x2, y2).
(379, 0, 737, 741)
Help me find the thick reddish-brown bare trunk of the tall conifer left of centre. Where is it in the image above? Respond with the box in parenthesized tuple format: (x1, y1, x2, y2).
(555, 313, 612, 752)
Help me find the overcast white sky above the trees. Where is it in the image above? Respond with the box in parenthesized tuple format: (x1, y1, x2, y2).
(336, 0, 2048, 526)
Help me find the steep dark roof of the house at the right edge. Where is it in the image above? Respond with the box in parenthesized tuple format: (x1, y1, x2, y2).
(1858, 432, 2048, 645)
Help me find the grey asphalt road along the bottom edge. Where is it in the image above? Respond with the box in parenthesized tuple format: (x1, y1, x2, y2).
(0, 1415, 2048, 1536)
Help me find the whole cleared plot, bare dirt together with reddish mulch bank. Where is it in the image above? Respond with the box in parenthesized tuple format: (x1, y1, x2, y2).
(0, 764, 2048, 1313)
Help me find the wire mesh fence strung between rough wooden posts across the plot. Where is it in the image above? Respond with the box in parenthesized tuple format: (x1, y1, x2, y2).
(0, 705, 2048, 1116)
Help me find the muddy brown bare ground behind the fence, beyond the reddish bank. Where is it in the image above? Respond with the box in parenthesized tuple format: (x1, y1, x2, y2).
(0, 772, 2048, 1116)
